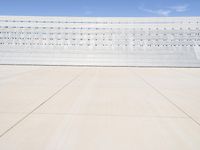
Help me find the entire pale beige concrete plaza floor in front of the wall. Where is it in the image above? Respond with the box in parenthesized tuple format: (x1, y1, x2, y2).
(0, 65, 200, 150)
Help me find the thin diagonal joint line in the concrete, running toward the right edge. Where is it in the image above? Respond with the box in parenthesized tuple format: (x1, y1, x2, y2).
(134, 72, 200, 126)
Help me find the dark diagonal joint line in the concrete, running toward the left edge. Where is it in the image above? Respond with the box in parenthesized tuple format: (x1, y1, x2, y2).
(0, 69, 86, 138)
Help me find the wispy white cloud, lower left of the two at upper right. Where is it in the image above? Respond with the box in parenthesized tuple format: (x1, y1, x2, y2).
(139, 7, 172, 16)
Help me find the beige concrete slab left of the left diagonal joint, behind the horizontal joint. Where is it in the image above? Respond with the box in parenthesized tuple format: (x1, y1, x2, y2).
(0, 67, 82, 113)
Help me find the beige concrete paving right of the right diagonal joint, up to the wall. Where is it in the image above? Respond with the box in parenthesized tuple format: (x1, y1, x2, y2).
(134, 68, 200, 123)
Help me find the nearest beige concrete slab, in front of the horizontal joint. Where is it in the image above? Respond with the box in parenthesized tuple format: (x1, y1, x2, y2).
(0, 115, 200, 150)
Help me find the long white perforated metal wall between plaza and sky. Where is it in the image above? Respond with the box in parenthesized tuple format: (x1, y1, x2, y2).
(0, 16, 200, 67)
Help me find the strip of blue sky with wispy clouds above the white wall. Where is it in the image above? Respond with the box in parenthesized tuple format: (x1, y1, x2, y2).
(0, 0, 200, 17)
